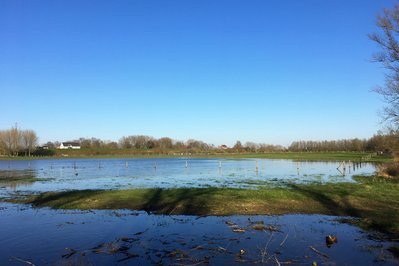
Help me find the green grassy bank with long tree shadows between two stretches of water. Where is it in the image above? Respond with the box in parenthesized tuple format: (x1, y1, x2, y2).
(13, 177, 399, 239)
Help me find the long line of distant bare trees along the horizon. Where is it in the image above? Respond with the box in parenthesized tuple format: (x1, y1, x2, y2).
(0, 127, 399, 156)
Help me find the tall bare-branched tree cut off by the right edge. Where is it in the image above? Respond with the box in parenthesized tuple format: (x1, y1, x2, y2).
(369, 4, 399, 128)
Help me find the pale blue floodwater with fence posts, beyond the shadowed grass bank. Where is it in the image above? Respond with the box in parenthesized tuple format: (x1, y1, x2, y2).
(0, 158, 375, 196)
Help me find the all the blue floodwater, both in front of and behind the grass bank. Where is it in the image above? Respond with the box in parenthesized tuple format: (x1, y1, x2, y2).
(0, 159, 398, 265)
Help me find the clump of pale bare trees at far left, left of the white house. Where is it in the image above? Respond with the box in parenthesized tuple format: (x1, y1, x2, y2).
(0, 127, 39, 156)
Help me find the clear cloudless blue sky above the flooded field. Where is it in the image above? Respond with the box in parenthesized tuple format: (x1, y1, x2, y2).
(0, 0, 395, 145)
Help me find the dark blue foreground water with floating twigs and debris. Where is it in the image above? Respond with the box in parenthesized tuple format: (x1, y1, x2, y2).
(0, 203, 397, 265)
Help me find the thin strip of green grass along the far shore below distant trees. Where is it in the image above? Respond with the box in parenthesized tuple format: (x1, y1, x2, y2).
(0, 149, 393, 163)
